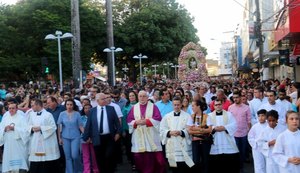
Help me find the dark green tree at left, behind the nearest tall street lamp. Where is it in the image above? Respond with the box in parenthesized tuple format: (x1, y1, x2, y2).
(0, 0, 105, 80)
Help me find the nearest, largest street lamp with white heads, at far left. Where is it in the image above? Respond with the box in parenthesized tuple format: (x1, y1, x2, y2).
(45, 31, 73, 91)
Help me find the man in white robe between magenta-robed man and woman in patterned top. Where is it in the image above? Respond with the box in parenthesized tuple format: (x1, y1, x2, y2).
(160, 97, 194, 173)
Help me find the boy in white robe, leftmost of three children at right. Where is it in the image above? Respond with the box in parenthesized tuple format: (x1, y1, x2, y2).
(248, 109, 268, 173)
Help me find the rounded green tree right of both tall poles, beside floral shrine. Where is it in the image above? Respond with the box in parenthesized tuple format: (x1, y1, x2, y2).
(115, 0, 199, 81)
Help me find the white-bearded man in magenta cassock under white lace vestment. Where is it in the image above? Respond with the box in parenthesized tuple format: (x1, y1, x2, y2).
(127, 91, 165, 173)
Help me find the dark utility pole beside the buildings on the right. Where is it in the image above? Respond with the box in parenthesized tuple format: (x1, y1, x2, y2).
(255, 0, 264, 83)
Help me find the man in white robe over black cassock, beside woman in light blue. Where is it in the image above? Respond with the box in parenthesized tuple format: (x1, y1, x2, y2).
(27, 99, 60, 173)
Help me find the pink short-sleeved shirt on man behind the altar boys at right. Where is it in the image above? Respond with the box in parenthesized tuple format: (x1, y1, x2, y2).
(228, 103, 251, 137)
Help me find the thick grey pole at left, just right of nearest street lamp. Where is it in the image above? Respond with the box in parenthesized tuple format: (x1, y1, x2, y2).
(71, 0, 82, 88)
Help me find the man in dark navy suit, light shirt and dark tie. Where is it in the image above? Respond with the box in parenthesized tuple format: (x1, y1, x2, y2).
(82, 93, 121, 173)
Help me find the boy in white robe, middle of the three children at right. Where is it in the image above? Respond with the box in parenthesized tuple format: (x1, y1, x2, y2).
(257, 110, 286, 173)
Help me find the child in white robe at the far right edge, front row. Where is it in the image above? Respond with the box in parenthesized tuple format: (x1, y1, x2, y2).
(272, 111, 300, 173)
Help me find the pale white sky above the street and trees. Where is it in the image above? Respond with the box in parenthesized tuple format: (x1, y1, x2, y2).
(0, 0, 245, 59)
